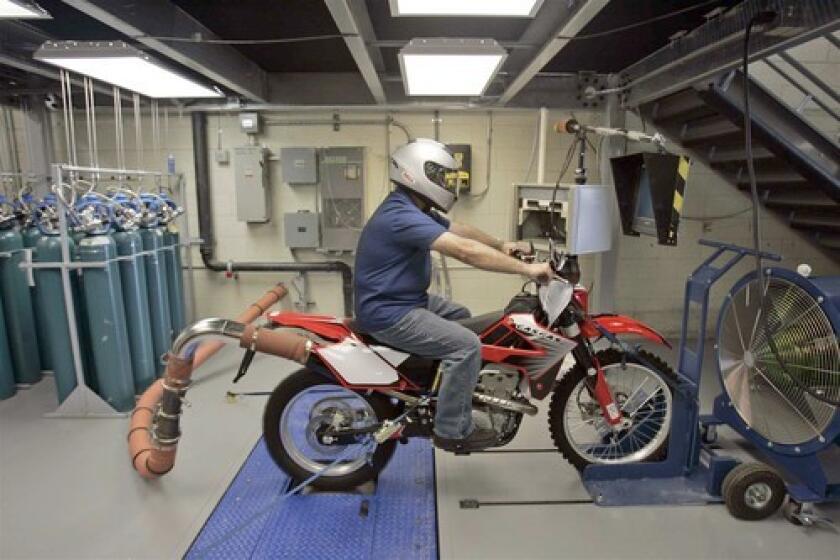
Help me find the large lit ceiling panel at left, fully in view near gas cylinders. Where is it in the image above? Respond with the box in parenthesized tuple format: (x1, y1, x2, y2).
(34, 41, 222, 99)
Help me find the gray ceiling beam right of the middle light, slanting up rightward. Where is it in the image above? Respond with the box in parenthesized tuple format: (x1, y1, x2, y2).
(499, 0, 609, 105)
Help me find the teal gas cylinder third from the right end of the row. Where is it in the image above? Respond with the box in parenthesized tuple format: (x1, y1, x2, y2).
(114, 225, 158, 393)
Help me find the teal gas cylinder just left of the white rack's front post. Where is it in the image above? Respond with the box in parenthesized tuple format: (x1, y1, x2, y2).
(35, 235, 79, 404)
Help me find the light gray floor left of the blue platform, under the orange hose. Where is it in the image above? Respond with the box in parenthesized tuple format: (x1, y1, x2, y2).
(0, 348, 295, 560)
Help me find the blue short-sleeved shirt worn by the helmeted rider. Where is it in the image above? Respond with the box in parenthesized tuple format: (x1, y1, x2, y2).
(355, 188, 449, 331)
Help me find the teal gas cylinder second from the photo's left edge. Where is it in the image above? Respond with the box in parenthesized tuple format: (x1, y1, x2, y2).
(0, 227, 41, 385)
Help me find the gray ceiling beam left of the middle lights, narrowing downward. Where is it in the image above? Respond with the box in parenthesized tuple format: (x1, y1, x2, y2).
(325, 0, 386, 105)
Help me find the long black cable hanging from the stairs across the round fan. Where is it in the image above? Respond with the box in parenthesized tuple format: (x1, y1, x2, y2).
(742, 11, 840, 406)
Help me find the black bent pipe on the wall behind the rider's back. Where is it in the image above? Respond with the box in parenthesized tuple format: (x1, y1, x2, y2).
(191, 112, 354, 317)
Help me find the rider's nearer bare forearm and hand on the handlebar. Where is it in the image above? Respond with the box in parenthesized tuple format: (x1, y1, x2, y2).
(431, 231, 552, 282)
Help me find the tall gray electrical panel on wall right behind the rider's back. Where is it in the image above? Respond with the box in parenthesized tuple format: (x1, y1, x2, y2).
(318, 148, 365, 251)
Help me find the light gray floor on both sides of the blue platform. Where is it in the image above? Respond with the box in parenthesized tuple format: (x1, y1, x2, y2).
(0, 340, 840, 559)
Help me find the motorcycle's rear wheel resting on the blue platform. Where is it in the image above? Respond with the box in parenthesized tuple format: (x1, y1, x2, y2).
(263, 369, 397, 491)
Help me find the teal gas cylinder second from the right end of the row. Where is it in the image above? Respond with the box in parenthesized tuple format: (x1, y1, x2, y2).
(140, 227, 174, 375)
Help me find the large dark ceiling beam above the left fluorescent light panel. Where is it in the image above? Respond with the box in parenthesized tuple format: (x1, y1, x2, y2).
(63, 0, 268, 102)
